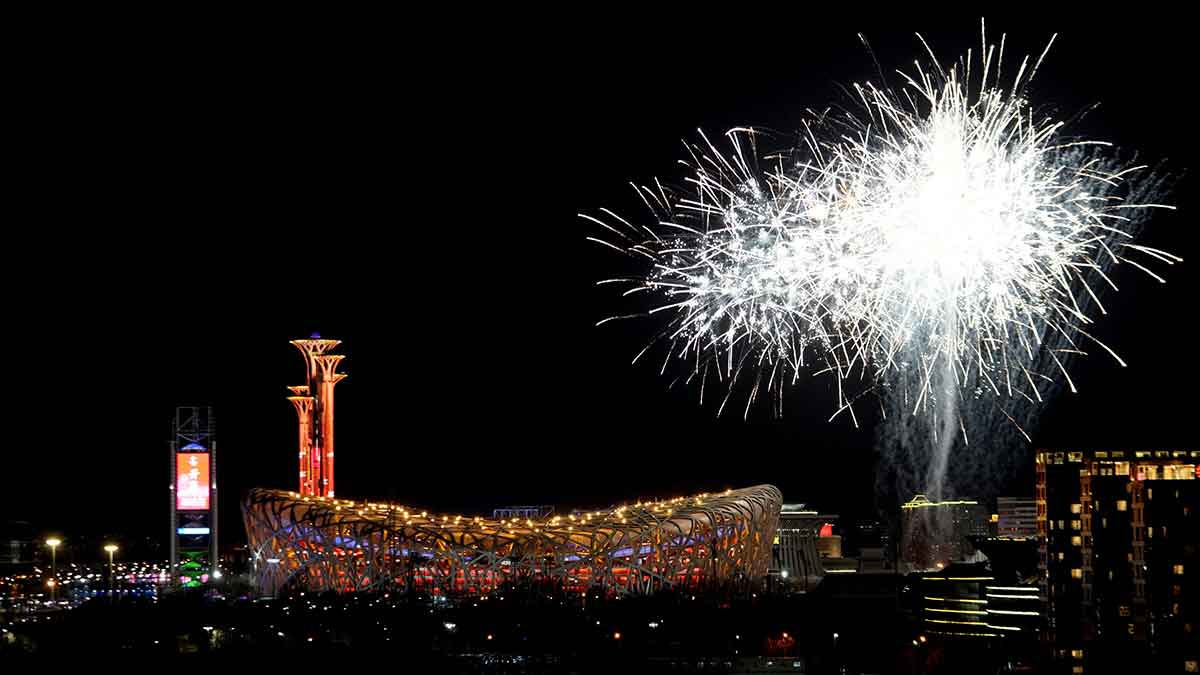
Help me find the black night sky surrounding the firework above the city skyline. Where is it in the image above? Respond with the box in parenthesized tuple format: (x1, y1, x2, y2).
(0, 12, 1200, 552)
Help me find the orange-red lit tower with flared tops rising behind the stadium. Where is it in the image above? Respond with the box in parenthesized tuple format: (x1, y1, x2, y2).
(288, 336, 346, 497)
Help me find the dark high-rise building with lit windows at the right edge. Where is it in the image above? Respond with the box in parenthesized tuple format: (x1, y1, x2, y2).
(1034, 450, 1200, 673)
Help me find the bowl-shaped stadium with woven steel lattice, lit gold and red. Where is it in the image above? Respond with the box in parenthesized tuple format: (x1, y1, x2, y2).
(242, 485, 782, 595)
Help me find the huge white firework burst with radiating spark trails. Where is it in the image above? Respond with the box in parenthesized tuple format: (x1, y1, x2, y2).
(584, 23, 1181, 441)
